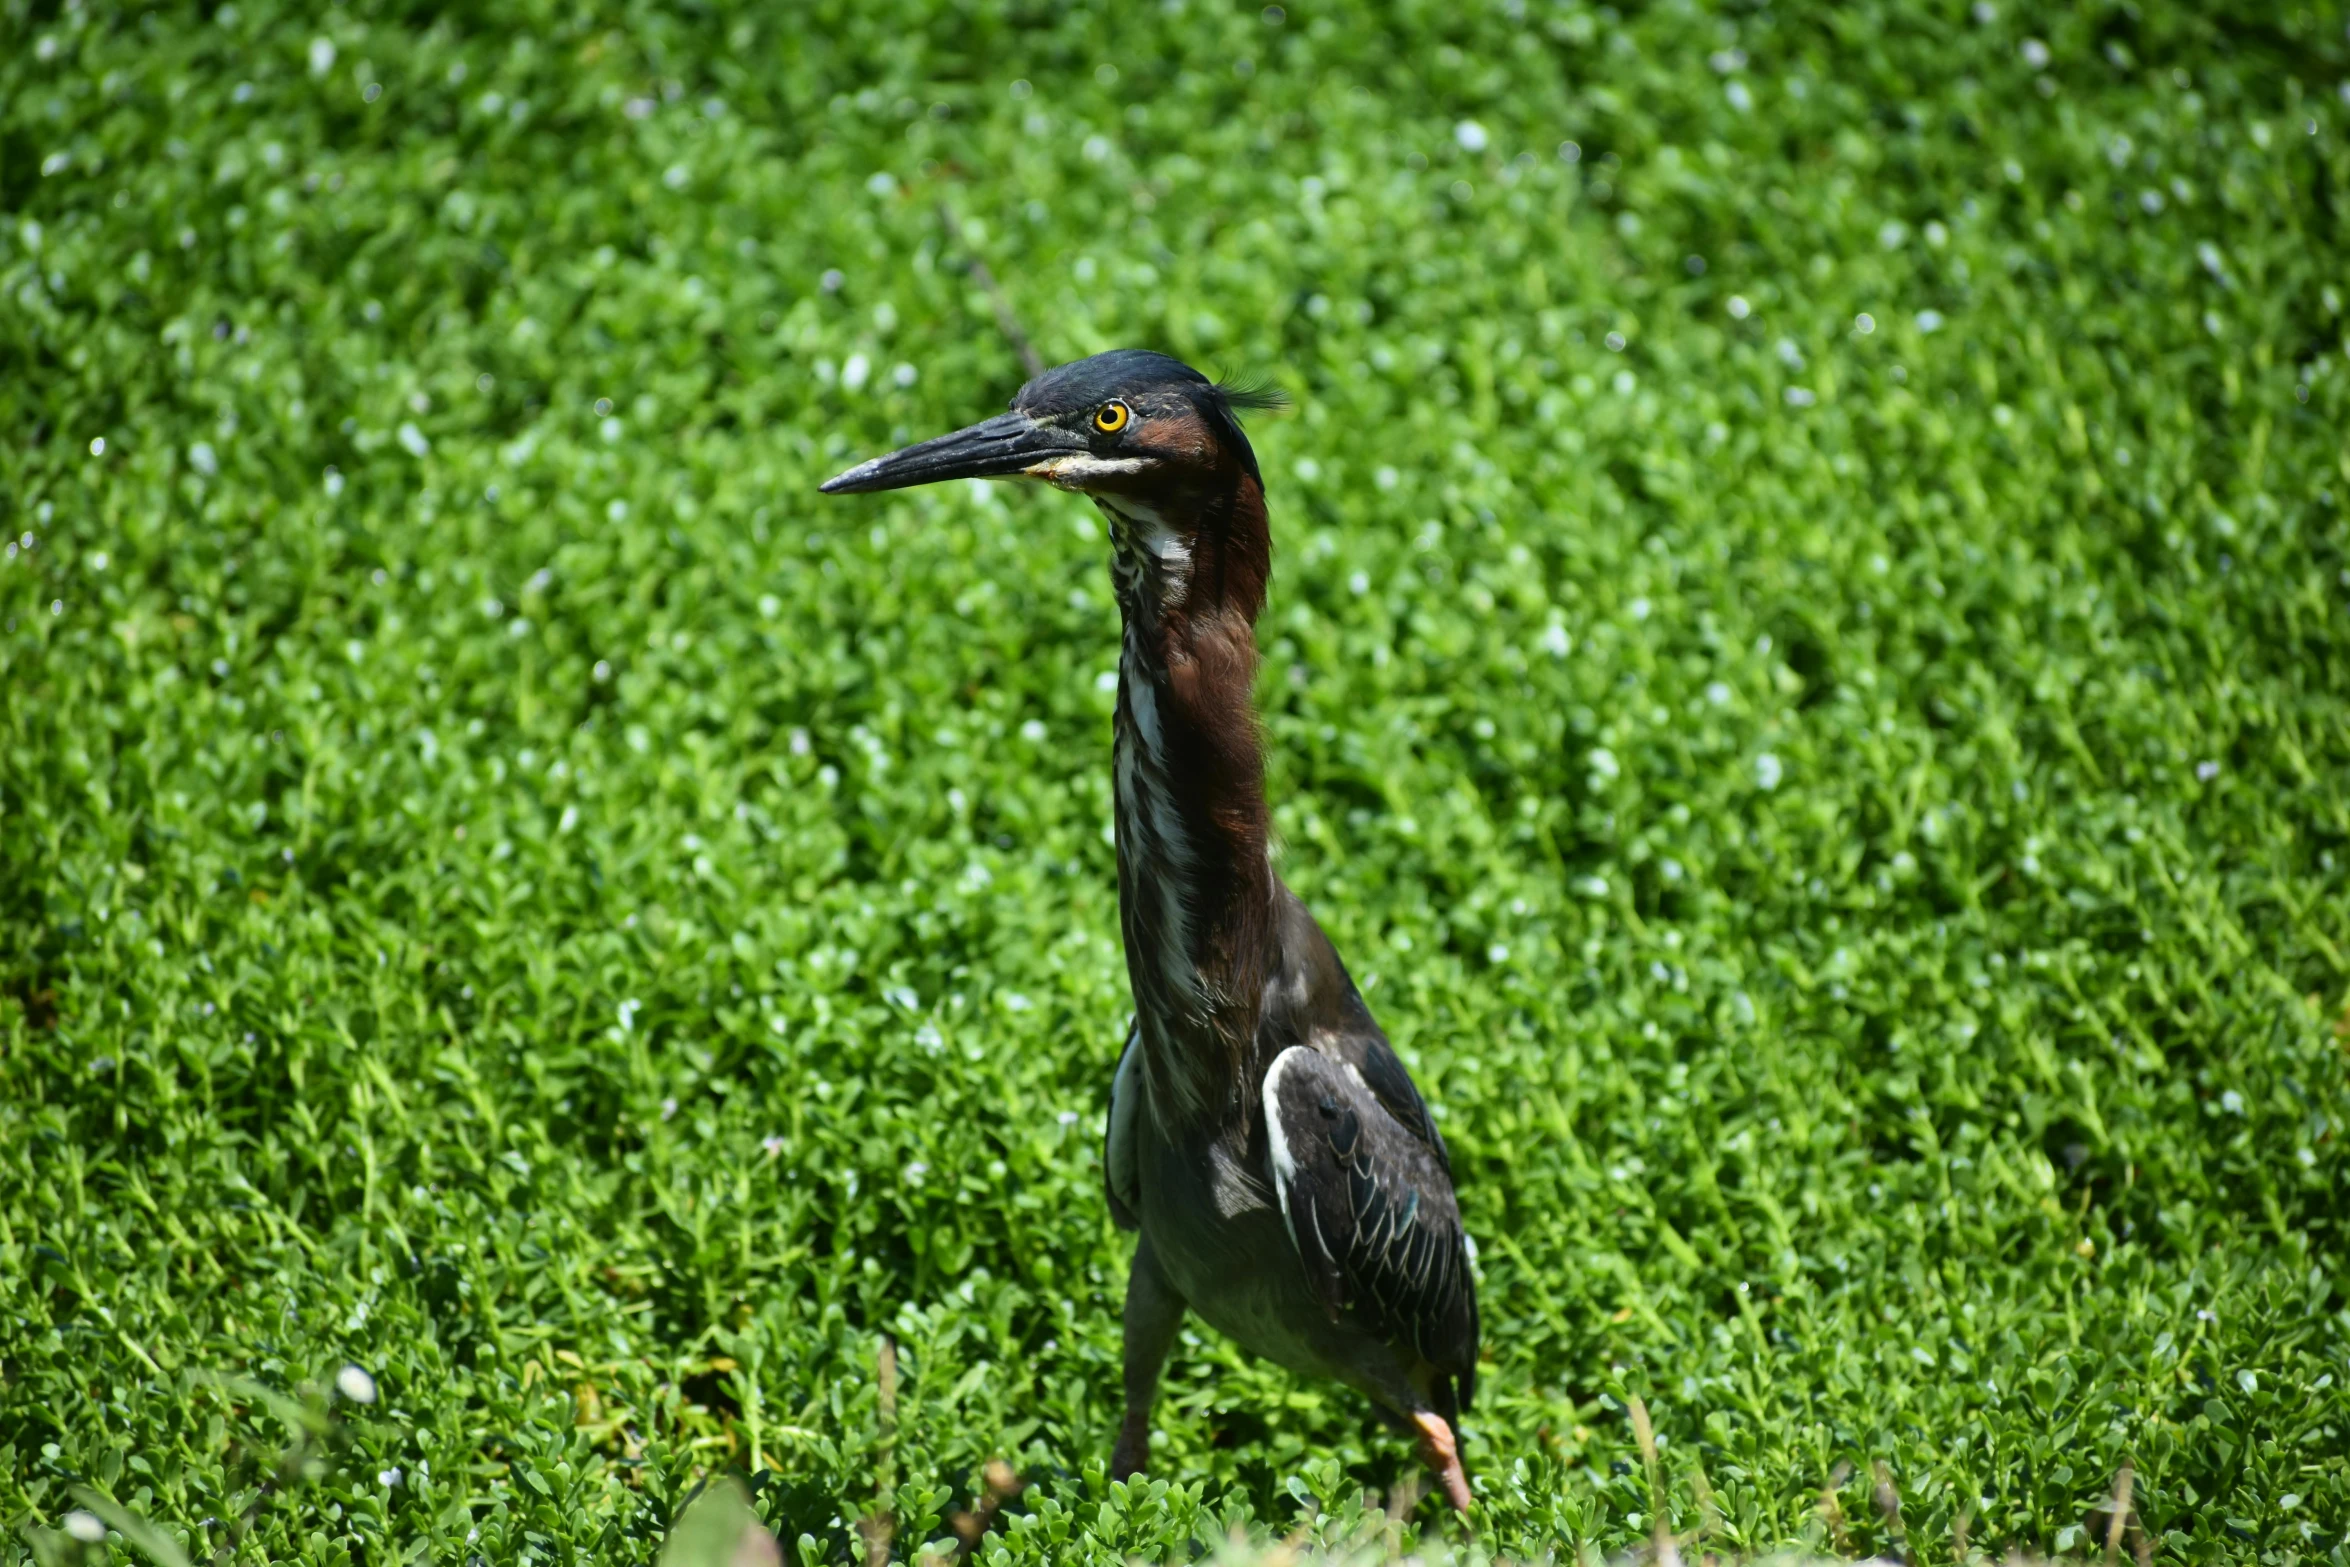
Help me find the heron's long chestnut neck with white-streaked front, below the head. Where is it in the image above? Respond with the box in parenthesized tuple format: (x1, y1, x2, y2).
(1102, 472, 1274, 1116)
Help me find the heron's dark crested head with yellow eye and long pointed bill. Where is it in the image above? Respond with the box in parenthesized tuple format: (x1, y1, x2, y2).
(823, 348, 1281, 496)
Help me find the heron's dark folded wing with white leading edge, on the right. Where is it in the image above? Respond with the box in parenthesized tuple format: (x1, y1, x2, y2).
(1264, 1045, 1478, 1405)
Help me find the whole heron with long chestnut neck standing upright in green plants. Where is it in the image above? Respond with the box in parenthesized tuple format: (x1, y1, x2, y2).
(820, 348, 1478, 1513)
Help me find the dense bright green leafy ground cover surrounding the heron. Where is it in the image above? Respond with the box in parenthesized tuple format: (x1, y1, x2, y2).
(0, 0, 2350, 1567)
